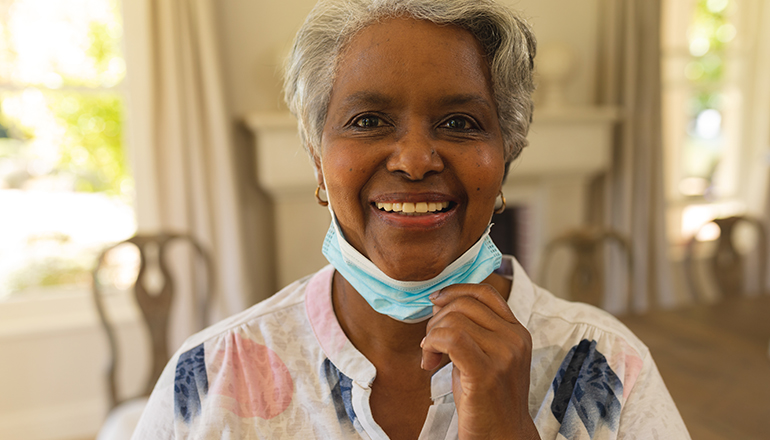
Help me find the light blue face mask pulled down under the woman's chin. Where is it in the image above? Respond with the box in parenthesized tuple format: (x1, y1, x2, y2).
(323, 213, 502, 323)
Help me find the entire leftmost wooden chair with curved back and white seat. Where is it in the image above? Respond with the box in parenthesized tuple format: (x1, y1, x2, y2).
(92, 233, 214, 440)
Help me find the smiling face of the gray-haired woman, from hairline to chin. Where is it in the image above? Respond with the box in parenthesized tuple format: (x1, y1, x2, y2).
(316, 19, 505, 280)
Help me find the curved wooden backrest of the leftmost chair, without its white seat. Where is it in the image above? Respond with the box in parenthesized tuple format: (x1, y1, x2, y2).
(92, 233, 214, 408)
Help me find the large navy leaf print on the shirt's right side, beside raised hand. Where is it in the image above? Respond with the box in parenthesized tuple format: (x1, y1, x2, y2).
(551, 339, 623, 438)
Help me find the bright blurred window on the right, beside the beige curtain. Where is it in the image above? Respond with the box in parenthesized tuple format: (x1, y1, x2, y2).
(661, 0, 761, 243)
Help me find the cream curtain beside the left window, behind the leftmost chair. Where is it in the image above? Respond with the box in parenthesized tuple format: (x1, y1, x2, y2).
(124, 0, 249, 344)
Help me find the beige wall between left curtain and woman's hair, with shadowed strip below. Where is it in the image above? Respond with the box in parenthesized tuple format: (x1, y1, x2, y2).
(216, 0, 315, 304)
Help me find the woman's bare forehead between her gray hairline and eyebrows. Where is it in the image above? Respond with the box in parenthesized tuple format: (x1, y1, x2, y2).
(332, 18, 492, 107)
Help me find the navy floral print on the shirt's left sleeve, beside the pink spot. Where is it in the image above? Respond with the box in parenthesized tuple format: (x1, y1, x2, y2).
(174, 344, 209, 424)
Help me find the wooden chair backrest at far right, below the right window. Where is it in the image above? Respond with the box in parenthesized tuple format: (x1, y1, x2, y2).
(685, 215, 768, 300)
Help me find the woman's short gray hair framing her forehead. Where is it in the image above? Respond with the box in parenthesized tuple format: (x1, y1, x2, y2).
(284, 0, 536, 163)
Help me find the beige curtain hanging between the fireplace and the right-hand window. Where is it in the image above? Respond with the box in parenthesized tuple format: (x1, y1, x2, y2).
(599, 0, 674, 312)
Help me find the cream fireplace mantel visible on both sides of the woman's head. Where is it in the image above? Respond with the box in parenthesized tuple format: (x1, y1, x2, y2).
(244, 107, 620, 287)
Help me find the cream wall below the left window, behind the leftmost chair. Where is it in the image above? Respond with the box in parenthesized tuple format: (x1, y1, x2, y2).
(0, 291, 148, 440)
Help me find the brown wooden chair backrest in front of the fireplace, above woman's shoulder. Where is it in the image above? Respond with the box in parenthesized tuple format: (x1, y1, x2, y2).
(538, 228, 633, 310)
